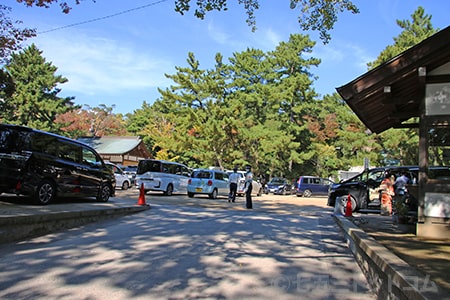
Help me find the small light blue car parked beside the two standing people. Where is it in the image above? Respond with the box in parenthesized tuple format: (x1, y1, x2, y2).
(187, 169, 230, 199)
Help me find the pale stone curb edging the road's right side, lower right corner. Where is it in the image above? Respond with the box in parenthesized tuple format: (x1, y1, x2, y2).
(333, 215, 450, 300)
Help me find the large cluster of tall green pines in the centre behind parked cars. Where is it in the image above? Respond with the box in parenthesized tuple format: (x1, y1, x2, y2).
(128, 35, 330, 176)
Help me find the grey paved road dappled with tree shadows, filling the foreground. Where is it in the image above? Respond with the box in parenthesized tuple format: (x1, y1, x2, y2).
(0, 190, 376, 300)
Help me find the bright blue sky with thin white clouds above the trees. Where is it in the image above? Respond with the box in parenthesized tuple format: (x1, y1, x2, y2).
(2, 0, 450, 114)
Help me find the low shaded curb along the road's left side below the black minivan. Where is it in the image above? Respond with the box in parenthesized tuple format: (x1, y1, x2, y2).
(0, 206, 150, 244)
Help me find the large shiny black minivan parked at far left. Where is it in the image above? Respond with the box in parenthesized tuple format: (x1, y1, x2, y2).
(0, 124, 116, 205)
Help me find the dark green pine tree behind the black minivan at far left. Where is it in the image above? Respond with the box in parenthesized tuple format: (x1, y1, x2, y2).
(0, 44, 73, 132)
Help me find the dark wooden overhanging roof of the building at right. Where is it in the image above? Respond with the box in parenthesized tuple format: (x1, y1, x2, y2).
(336, 26, 450, 133)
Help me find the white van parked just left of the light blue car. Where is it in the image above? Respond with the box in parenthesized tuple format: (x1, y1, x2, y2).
(136, 159, 191, 196)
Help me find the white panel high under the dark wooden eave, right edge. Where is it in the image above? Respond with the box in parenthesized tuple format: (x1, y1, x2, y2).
(425, 82, 450, 116)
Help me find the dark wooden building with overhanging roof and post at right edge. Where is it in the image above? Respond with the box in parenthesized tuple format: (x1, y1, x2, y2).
(336, 26, 450, 238)
